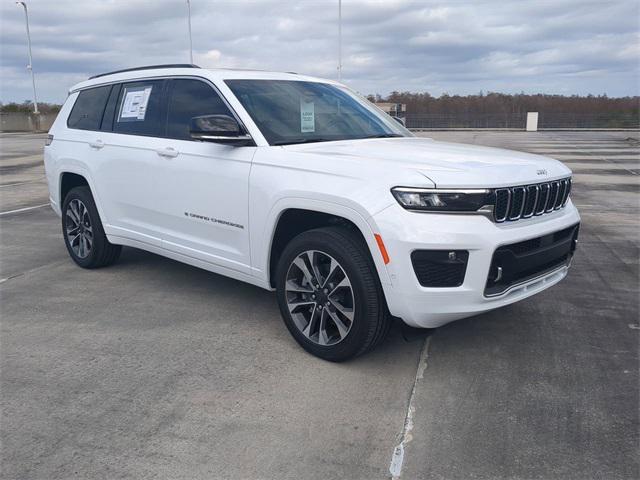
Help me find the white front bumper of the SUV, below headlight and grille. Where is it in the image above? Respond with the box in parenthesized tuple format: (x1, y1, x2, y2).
(373, 200, 580, 328)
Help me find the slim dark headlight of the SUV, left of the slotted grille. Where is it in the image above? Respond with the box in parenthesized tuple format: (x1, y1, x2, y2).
(391, 187, 493, 212)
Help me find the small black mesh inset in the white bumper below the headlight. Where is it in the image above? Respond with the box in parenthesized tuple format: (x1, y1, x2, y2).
(411, 250, 469, 287)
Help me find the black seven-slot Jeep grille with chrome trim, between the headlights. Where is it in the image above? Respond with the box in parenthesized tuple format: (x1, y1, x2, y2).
(493, 178, 571, 222)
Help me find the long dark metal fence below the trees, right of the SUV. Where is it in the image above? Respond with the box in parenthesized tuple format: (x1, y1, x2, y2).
(404, 112, 640, 130)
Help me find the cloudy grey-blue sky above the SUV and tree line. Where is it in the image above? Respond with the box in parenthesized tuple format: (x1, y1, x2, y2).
(0, 0, 640, 102)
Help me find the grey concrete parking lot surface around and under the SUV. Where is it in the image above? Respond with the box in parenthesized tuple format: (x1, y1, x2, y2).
(0, 132, 640, 479)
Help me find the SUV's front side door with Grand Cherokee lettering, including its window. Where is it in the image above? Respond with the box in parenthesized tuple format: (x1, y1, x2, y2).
(154, 78, 255, 273)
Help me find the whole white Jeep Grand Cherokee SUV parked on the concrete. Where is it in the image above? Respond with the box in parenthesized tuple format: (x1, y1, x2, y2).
(45, 65, 580, 361)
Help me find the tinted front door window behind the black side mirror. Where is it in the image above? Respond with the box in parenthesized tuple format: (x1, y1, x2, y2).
(167, 79, 233, 140)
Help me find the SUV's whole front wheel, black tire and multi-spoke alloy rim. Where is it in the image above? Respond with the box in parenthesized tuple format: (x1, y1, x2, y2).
(276, 227, 391, 362)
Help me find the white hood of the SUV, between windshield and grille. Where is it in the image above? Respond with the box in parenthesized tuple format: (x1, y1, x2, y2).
(284, 137, 571, 188)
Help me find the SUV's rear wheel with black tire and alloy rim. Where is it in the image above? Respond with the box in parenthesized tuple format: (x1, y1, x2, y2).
(62, 187, 122, 268)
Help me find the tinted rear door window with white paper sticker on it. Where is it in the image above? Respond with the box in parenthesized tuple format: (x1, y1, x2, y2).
(113, 80, 165, 137)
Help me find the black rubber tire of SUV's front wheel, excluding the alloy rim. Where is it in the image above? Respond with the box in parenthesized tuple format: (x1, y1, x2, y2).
(276, 230, 380, 361)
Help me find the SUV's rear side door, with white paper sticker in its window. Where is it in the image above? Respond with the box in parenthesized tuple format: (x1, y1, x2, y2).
(93, 79, 170, 246)
